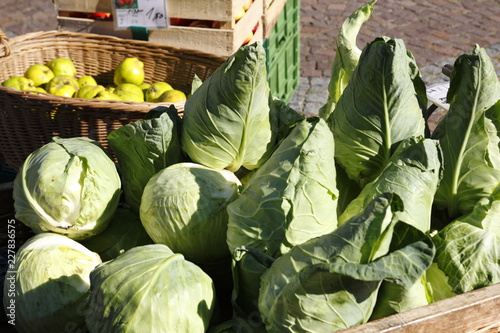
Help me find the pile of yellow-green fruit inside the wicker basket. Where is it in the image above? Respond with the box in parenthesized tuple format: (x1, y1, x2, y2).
(2, 58, 186, 103)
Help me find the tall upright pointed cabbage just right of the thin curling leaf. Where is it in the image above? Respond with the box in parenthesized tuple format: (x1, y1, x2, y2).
(328, 37, 426, 187)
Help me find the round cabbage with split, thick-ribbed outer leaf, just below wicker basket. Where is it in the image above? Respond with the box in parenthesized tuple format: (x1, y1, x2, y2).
(14, 137, 121, 240)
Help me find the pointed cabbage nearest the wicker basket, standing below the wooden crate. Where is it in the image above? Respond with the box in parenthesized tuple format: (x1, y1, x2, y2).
(182, 42, 277, 172)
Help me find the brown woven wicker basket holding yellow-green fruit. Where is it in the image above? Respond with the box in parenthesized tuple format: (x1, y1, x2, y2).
(0, 30, 227, 170)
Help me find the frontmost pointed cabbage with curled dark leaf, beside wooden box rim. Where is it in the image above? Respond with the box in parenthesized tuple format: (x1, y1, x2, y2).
(259, 193, 434, 332)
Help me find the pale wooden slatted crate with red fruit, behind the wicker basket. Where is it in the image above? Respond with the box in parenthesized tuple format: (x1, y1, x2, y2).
(54, 0, 266, 56)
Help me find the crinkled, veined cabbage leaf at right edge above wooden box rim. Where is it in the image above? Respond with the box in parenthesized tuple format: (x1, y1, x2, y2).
(431, 186, 500, 300)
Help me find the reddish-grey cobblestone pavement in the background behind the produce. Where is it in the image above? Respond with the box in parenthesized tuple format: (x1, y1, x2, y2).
(0, 0, 500, 115)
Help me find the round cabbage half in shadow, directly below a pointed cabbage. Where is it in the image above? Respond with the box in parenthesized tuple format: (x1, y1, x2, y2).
(140, 163, 241, 264)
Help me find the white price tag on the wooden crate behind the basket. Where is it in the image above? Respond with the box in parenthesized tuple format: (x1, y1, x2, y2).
(111, 0, 169, 30)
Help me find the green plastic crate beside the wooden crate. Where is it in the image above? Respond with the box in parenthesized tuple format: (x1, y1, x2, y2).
(263, 0, 300, 102)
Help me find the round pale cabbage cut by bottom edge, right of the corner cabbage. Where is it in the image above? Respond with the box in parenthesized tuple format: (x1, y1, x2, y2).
(85, 244, 215, 333)
